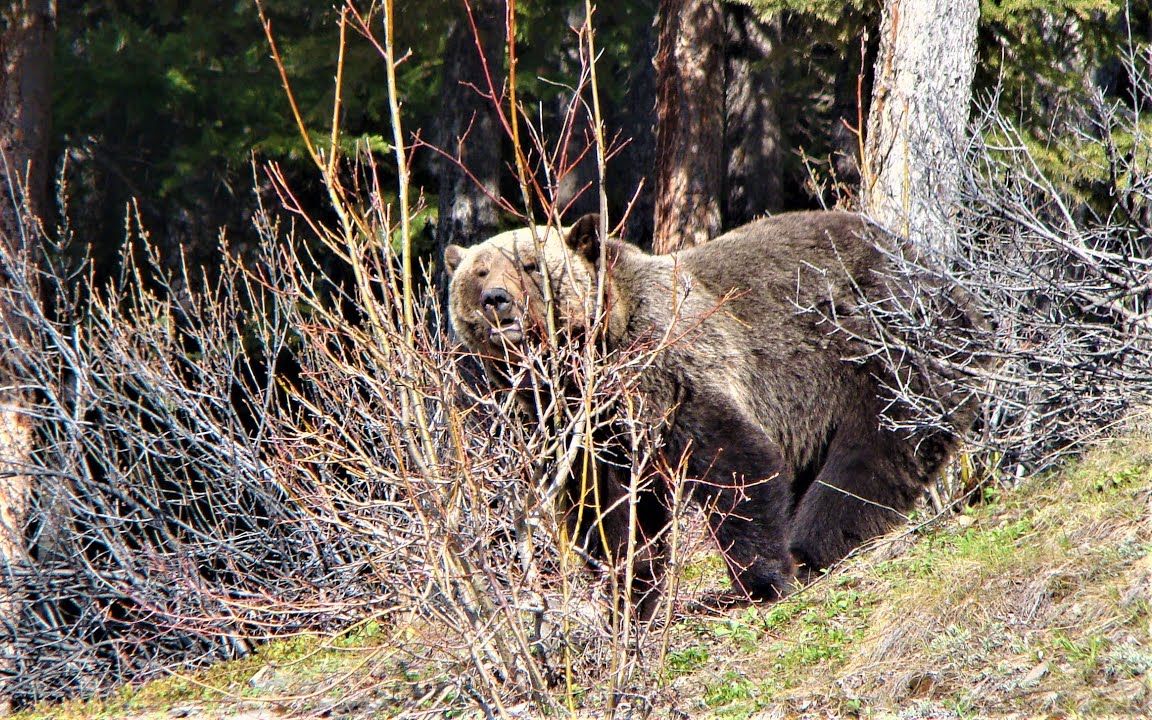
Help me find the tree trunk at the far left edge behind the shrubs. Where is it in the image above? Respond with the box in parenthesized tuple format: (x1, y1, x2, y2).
(0, 0, 56, 714)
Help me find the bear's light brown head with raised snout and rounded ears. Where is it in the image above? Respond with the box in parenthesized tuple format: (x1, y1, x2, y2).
(445, 215, 622, 357)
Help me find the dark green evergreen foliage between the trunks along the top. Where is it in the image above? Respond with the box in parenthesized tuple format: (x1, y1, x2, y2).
(54, 0, 1138, 265)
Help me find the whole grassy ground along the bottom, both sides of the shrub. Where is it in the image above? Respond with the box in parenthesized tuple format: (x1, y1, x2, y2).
(18, 420, 1152, 720)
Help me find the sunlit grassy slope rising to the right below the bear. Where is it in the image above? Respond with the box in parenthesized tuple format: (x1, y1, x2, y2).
(668, 426, 1152, 718)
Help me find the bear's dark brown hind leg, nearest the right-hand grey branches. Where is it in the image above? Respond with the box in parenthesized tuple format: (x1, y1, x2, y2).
(789, 426, 925, 578)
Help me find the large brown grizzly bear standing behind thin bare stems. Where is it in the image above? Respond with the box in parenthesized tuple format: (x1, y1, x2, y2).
(445, 212, 977, 616)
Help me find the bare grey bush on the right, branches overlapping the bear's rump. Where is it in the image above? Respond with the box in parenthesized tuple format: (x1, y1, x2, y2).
(846, 47, 1152, 477)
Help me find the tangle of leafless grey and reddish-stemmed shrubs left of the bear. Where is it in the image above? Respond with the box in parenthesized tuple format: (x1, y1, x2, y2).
(0, 1, 680, 714)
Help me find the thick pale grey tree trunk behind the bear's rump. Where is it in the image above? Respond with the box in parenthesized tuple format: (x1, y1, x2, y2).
(863, 0, 979, 252)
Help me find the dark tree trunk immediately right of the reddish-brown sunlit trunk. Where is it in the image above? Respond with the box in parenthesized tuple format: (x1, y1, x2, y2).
(721, 5, 783, 228)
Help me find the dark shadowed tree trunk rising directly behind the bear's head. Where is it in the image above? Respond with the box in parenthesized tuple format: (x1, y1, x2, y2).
(435, 0, 507, 286)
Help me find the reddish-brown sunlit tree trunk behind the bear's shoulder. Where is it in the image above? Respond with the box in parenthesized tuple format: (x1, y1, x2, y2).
(652, 0, 725, 252)
